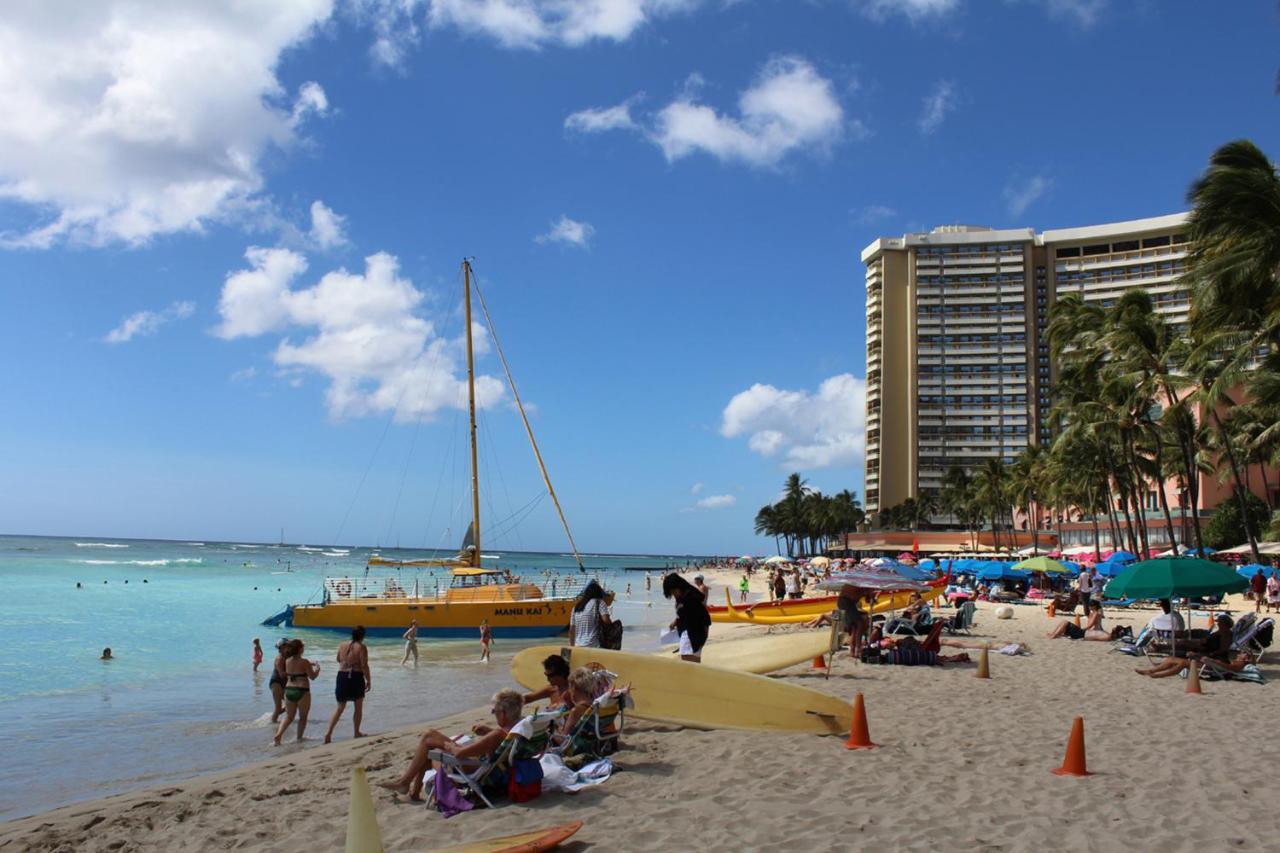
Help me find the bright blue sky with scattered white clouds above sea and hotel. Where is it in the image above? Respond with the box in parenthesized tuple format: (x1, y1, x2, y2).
(0, 0, 1280, 553)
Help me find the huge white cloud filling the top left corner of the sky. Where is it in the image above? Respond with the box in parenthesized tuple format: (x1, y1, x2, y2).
(0, 0, 332, 248)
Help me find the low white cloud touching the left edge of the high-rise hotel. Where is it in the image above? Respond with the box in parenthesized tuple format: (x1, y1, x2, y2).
(721, 373, 867, 469)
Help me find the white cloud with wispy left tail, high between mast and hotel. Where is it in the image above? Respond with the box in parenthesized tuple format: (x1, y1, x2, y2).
(576, 56, 844, 167)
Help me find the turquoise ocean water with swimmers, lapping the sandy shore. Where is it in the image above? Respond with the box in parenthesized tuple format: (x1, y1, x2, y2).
(0, 535, 690, 820)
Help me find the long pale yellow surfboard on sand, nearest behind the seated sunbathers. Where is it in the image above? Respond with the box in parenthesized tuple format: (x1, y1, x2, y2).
(511, 646, 852, 734)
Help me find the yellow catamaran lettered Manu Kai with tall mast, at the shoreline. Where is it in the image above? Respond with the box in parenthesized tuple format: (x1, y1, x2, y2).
(275, 261, 584, 638)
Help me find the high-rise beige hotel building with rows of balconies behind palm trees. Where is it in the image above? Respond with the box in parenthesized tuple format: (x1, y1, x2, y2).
(863, 214, 1188, 512)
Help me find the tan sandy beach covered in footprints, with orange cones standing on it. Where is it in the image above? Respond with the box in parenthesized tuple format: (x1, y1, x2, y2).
(0, 584, 1280, 853)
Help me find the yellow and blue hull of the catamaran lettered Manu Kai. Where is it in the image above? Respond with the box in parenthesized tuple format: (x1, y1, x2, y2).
(287, 598, 573, 639)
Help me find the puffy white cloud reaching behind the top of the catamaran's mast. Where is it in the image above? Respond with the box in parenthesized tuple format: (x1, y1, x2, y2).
(214, 247, 504, 420)
